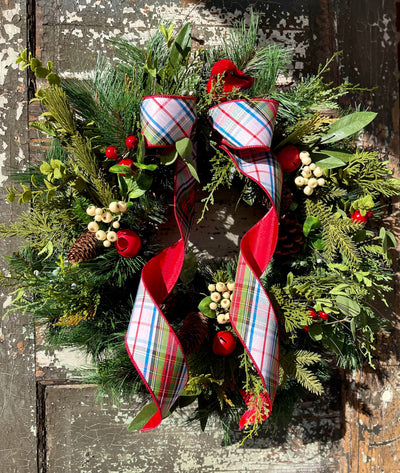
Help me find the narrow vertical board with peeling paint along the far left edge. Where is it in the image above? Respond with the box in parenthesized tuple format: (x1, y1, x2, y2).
(0, 0, 37, 473)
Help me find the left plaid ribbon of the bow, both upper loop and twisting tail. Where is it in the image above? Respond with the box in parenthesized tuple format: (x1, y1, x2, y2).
(125, 96, 196, 431)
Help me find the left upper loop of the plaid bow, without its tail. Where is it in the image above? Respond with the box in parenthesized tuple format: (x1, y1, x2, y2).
(140, 95, 196, 147)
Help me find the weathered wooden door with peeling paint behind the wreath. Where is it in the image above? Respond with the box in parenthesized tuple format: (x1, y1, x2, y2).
(0, 0, 400, 473)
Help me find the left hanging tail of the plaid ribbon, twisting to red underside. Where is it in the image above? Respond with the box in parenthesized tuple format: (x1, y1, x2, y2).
(125, 97, 196, 431)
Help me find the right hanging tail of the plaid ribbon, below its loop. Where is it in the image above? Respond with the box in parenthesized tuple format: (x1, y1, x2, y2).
(223, 148, 281, 411)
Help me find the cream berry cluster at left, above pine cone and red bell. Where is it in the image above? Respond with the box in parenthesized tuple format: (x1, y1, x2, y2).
(86, 200, 128, 248)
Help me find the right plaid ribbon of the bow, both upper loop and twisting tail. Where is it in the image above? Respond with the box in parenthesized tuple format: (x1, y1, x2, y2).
(209, 99, 282, 408)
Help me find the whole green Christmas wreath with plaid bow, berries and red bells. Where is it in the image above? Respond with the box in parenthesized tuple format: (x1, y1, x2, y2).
(0, 15, 400, 438)
